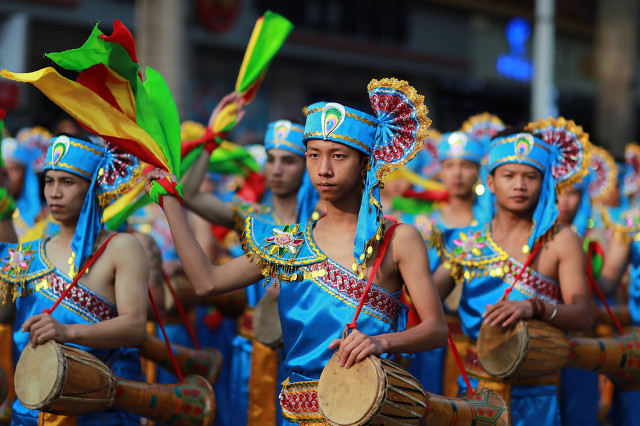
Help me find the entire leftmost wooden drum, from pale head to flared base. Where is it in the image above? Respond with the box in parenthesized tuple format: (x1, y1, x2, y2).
(15, 340, 216, 426)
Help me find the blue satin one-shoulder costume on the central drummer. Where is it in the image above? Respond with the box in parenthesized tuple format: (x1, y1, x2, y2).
(244, 217, 406, 424)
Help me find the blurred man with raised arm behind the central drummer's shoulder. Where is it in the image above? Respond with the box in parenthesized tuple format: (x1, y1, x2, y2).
(182, 94, 318, 425)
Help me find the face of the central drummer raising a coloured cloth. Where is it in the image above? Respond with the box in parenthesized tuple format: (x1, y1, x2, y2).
(307, 139, 368, 201)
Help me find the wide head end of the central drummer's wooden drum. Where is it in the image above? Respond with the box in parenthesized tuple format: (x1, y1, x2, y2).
(318, 355, 428, 425)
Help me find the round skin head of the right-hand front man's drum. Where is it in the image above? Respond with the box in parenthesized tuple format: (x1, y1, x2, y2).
(478, 320, 529, 379)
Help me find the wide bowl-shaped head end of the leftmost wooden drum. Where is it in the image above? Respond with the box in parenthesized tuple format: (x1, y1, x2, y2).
(14, 340, 116, 416)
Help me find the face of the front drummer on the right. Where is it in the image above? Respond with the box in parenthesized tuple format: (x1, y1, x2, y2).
(487, 164, 542, 214)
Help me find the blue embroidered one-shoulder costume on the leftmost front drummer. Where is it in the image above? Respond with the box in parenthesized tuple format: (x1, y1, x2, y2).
(0, 239, 142, 426)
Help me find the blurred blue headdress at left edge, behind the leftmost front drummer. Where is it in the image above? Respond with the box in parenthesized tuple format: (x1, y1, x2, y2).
(2, 138, 42, 228)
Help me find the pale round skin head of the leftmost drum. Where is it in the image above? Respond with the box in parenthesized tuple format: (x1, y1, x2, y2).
(14, 340, 67, 410)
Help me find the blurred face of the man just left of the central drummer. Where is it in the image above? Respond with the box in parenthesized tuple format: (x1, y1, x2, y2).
(264, 148, 305, 197)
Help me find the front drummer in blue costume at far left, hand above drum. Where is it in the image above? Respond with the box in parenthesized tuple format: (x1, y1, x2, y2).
(0, 135, 149, 426)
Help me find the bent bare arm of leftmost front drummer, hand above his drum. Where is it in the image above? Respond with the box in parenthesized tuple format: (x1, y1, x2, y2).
(22, 234, 149, 349)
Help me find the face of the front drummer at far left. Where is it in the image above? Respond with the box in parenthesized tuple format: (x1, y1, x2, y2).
(44, 170, 90, 223)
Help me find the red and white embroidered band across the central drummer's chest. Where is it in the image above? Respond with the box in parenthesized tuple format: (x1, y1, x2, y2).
(304, 259, 401, 323)
